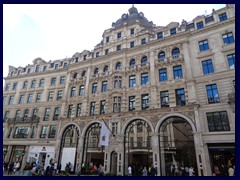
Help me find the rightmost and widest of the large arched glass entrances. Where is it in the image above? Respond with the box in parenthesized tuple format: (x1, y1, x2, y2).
(158, 116, 197, 176)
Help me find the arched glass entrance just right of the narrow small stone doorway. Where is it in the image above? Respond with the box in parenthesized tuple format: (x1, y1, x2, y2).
(124, 119, 153, 176)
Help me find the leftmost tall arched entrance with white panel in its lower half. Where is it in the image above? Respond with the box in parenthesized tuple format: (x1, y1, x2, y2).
(58, 124, 80, 173)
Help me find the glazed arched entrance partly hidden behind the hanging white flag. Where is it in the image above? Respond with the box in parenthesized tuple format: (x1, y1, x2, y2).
(82, 122, 104, 173)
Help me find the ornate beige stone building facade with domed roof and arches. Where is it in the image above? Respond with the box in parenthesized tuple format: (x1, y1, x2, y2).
(3, 4, 235, 176)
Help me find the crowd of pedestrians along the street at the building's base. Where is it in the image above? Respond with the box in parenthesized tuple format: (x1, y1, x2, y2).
(3, 160, 235, 176)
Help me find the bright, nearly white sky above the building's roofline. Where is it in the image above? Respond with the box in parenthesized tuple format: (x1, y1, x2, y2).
(3, 4, 225, 83)
